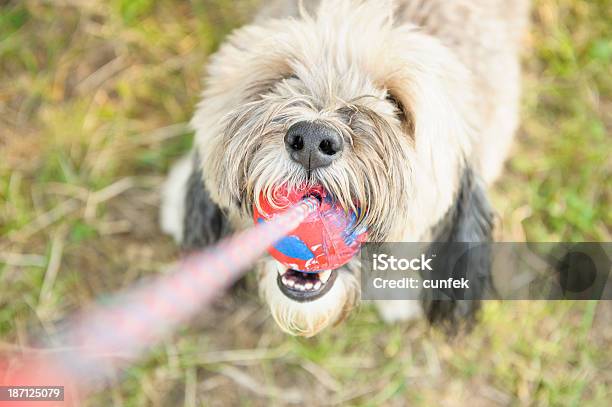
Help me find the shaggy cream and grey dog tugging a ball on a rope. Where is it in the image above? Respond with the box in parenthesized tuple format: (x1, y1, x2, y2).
(161, 0, 528, 336)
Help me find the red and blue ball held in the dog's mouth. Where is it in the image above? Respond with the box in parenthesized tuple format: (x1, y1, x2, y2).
(253, 186, 367, 272)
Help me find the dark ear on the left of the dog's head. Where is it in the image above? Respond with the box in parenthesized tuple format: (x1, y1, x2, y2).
(182, 155, 229, 250)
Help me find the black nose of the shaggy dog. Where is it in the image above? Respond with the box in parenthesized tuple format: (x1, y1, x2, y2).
(285, 122, 343, 170)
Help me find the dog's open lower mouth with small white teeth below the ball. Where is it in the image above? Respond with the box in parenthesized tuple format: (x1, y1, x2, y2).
(276, 269, 338, 302)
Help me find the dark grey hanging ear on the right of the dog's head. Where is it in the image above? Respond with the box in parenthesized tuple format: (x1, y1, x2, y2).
(423, 168, 493, 329)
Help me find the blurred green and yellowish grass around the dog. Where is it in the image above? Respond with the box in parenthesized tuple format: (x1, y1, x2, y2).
(0, 0, 612, 406)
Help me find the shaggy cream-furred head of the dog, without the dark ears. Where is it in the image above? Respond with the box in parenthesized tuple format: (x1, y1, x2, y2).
(193, 0, 488, 335)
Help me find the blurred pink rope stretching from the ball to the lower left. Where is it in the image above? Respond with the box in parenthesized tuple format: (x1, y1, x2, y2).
(0, 198, 319, 400)
